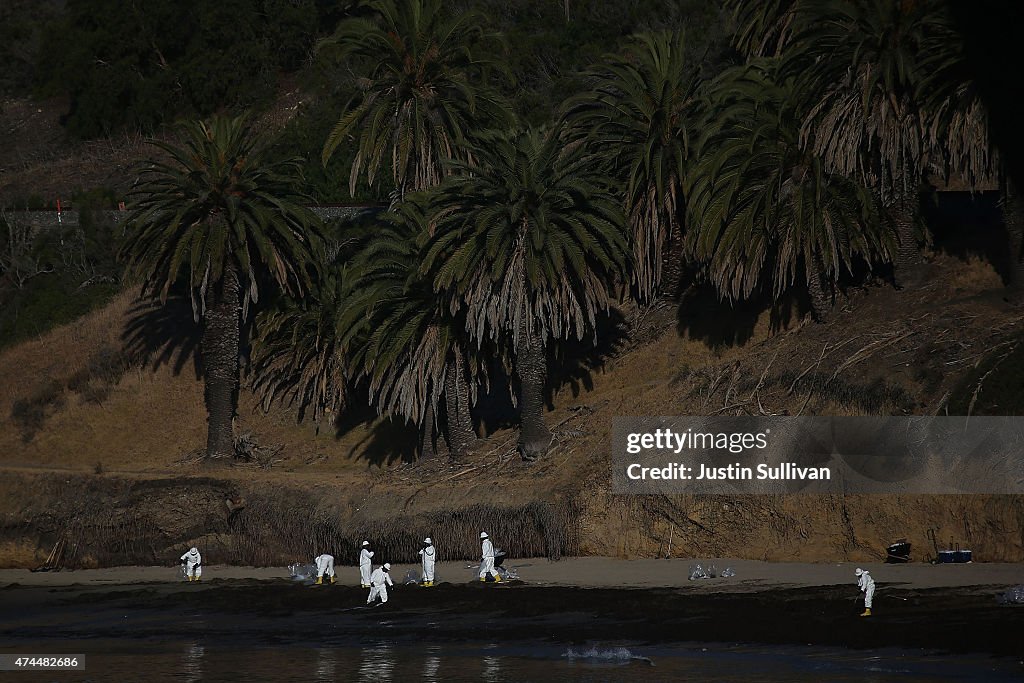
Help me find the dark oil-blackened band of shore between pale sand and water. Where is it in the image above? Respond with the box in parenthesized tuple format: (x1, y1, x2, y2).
(0, 579, 1024, 657)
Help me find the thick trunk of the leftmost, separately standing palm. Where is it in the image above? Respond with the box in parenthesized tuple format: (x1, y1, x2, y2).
(202, 266, 242, 458)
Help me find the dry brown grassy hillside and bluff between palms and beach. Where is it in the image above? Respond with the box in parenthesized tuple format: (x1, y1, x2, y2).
(0, 256, 1024, 566)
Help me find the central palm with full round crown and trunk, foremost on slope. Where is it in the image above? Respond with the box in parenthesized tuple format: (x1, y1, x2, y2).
(423, 130, 629, 460)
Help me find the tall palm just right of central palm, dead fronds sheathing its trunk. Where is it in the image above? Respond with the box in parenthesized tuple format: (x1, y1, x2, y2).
(565, 32, 698, 301)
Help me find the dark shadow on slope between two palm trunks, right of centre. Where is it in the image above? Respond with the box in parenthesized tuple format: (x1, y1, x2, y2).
(676, 284, 798, 349)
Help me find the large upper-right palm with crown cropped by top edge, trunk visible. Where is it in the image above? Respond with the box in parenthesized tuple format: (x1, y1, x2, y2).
(785, 0, 938, 279)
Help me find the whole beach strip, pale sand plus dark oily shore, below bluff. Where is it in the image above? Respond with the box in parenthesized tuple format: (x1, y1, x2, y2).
(0, 558, 1024, 659)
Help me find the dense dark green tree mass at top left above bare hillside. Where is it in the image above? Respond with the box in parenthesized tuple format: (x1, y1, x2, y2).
(37, 0, 317, 137)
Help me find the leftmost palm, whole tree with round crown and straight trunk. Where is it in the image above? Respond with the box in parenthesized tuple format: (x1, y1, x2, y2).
(122, 117, 319, 458)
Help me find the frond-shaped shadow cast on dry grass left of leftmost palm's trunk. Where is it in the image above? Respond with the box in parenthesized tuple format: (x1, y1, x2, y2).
(121, 295, 203, 380)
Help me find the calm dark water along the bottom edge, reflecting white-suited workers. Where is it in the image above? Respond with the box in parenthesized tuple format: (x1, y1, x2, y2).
(0, 640, 1024, 683)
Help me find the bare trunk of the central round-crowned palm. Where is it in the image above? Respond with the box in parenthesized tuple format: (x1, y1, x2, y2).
(515, 322, 552, 460)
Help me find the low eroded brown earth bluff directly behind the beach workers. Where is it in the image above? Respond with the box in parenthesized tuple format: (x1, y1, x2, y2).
(0, 472, 1024, 568)
